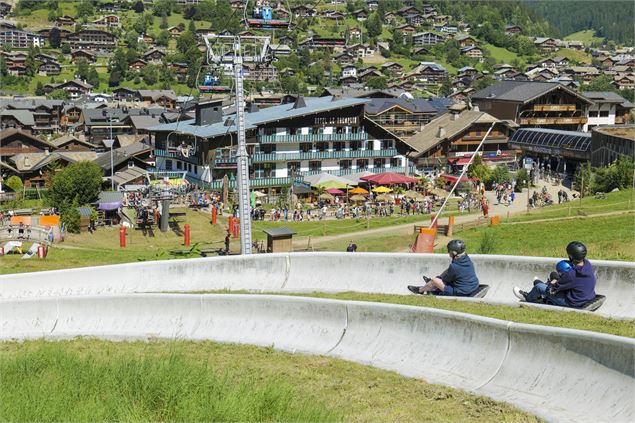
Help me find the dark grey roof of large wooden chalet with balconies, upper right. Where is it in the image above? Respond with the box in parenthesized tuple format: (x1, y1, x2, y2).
(472, 81, 593, 103)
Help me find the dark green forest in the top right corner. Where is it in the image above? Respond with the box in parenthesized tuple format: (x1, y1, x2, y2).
(524, 0, 635, 45)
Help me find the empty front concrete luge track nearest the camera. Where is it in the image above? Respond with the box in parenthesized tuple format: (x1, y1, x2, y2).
(0, 294, 635, 423)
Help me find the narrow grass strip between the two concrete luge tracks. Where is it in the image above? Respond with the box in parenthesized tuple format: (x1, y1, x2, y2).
(197, 294, 635, 338)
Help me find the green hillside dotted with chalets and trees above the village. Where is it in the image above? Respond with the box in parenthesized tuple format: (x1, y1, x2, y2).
(0, 0, 628, 96)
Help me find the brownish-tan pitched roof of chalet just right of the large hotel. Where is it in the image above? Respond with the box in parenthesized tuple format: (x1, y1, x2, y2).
(404, 110, 516, 156)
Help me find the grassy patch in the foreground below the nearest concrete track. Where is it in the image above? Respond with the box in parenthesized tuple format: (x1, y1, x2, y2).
(0, 339, 538, 422)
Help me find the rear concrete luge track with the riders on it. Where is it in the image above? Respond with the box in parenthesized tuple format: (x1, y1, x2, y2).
(0, 253, 635, 318)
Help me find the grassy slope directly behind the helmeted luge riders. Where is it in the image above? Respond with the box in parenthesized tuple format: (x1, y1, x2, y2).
(313, 190, 635, 260)
